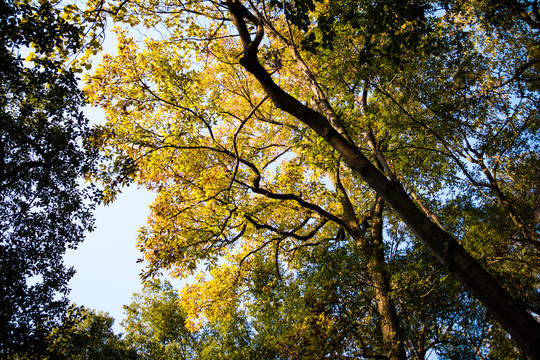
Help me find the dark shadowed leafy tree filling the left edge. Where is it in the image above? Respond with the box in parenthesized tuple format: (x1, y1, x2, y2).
(0, 1, 96, 356)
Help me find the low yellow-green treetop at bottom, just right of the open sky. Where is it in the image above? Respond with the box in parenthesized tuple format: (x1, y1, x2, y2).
(122, 281, 265, 360)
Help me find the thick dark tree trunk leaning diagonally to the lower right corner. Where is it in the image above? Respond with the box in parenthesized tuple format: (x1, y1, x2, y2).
(227, 0, 540, 360)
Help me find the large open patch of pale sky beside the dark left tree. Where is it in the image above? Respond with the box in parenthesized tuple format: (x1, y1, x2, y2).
(64, 186, 155, 332)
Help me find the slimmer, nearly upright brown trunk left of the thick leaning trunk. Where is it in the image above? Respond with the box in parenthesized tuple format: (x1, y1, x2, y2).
(362, 196, 407, 360)
